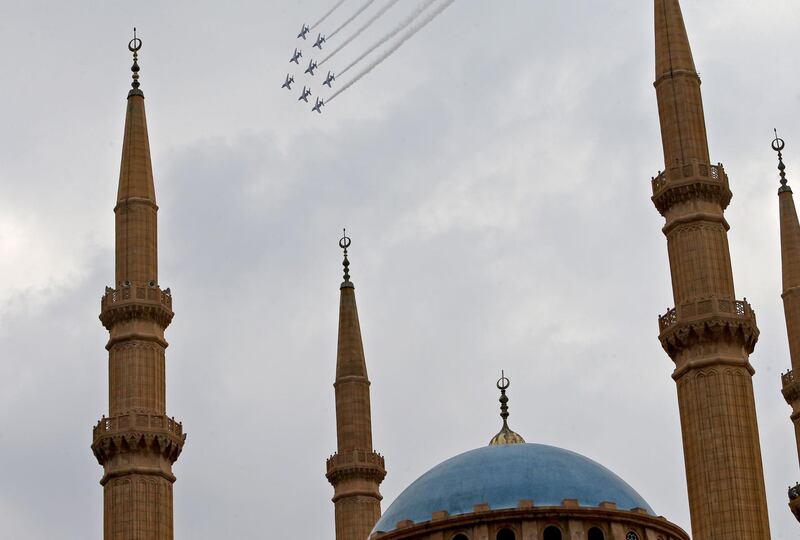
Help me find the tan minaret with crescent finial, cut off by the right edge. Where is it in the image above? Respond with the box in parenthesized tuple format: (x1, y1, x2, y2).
(772, 130, 800, 520)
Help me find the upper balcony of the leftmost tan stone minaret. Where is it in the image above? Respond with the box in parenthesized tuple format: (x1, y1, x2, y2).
(100, 282, 174, 330)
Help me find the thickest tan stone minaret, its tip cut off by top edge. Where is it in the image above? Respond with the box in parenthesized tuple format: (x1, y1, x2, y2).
(652, 0, 770, 540)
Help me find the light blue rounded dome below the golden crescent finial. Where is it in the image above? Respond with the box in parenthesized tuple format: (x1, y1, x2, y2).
(373, 444, 655, 532)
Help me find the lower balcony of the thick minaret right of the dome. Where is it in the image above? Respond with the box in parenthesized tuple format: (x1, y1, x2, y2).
(658, 298, 759, 358)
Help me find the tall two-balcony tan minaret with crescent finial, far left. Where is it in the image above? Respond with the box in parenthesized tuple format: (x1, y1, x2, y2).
(92, 29, 186, 540)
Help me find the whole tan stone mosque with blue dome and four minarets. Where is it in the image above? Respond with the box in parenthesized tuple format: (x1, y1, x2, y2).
(92, 0, 800, 540)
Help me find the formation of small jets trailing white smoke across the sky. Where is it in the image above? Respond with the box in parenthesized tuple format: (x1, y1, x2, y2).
(281, 0, 456, 114)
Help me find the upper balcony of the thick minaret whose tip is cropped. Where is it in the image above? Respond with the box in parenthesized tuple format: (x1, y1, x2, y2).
(651, 161, 732, 214)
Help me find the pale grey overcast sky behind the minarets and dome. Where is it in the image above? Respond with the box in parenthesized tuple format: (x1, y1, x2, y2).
(0, 0, 800, 540)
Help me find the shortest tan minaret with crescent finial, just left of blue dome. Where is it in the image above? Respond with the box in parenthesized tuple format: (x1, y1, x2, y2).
(326, 235, 386, 540)
